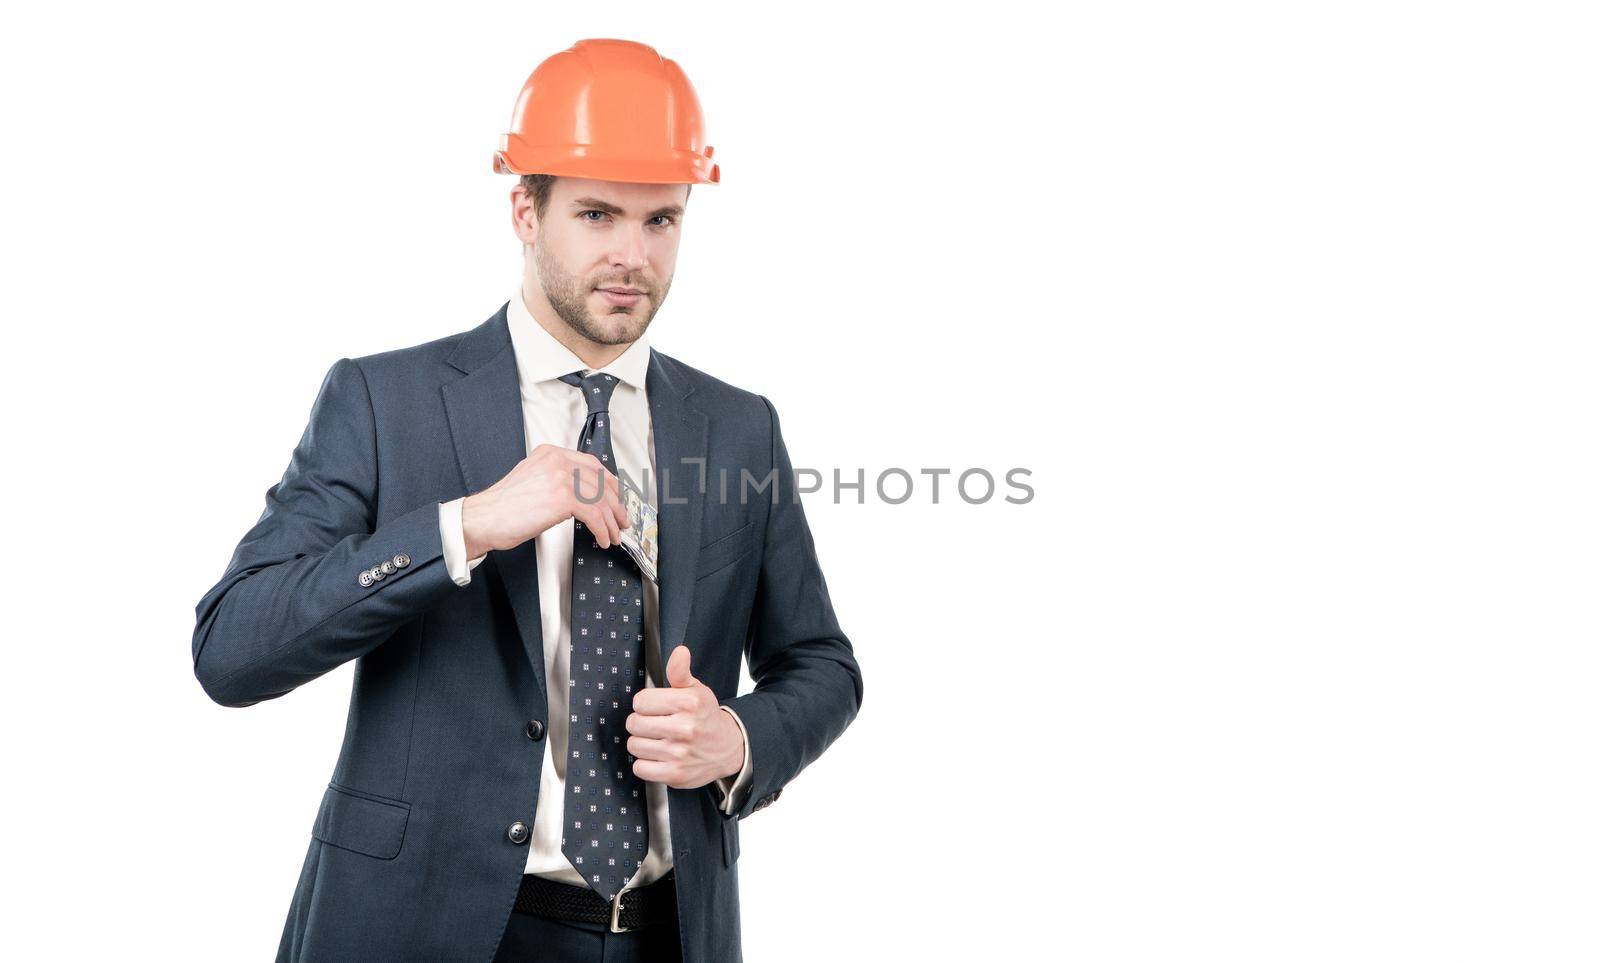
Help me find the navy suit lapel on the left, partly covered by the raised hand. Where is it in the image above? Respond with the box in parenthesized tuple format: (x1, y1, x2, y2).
(443, 302, 546, 697)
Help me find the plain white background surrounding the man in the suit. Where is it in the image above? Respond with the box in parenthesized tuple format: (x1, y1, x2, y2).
(0, 2, 1600, 963)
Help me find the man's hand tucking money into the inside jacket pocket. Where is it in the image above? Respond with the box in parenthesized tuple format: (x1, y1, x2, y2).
(461, 445, 627, 558)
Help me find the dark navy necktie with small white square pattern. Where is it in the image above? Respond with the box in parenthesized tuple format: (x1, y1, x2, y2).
(562, 373, 650, 902)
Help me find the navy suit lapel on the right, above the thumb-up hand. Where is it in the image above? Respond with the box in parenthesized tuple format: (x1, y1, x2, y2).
(645, 349, 709, 670)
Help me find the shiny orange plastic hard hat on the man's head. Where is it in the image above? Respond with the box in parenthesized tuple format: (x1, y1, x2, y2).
(494, 40, 722, 184)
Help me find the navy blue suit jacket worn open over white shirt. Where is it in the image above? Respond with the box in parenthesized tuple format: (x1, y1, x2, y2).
(194, 306, 862, 963)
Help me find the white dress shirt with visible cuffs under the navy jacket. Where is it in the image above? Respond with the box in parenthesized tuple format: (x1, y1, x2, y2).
(438, 286, 752, 889)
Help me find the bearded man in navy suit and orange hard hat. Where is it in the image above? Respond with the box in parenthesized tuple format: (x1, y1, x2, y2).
(194, 40, 862, 963)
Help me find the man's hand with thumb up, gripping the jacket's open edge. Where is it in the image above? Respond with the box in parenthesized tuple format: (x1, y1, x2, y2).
(626, 645, 744, 789)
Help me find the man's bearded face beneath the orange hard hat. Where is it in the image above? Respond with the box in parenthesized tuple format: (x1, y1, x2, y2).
(515, 178, 688, 346)
